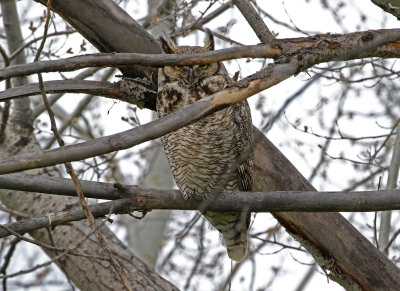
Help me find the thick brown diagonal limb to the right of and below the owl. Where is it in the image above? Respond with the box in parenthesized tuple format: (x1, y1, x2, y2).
(254, 131, 400, 291)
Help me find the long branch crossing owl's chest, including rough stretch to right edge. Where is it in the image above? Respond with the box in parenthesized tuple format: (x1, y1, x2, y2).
(0, 30, 400, 174)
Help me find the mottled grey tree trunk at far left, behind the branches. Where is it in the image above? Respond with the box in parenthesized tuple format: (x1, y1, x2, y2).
(0, 0, 176, 290)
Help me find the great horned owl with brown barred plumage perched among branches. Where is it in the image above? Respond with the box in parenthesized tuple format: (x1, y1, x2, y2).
(157, 30, 253, 260)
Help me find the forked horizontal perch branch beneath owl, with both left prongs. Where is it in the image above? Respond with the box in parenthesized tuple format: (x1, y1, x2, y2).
(0, 178, 400, 238)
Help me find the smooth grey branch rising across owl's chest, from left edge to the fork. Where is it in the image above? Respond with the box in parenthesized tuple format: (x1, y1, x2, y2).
(0, 59, 298, 174)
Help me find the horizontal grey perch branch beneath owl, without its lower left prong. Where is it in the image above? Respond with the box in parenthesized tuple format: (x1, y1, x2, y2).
(0, 174, 400, 215)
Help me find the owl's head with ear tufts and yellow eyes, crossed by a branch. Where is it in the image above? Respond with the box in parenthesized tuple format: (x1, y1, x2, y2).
(160, 29, 219, 87)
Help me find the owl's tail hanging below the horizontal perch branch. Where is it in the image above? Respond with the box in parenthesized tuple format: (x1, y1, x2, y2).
(204, 211, 250, 261)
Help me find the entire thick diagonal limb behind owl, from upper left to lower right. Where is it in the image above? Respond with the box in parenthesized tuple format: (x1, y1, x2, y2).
(2, 0, 400, 290)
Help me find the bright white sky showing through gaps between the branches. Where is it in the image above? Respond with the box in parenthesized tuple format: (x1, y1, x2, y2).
(0, 0, 399, 291)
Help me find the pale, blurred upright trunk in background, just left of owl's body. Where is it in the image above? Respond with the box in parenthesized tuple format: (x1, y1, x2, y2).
(119, 0, 177, 270)
